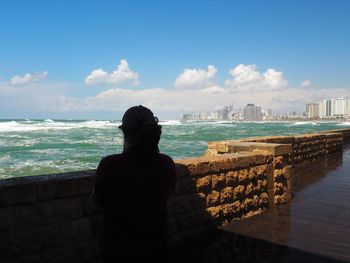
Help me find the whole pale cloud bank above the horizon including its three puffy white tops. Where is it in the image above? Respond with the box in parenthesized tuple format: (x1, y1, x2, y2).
(0, 60, 350, 118)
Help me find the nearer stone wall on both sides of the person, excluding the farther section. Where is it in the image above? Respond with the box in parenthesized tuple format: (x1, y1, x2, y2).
(0, 152, 274, 263)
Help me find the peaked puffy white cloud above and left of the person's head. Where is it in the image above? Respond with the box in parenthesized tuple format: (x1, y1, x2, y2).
(85, 59, 139, 85)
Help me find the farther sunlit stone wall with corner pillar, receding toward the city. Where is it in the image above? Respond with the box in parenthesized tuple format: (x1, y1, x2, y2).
(206, 129, 350, 205)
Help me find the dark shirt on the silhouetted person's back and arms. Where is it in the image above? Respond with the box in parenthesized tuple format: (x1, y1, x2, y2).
(94, 150, 176, 256)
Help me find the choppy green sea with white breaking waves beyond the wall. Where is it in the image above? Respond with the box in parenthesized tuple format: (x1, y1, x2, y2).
(0, 119, 350, 179)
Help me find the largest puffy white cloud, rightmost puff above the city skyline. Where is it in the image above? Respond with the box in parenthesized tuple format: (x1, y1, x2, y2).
(225, 64, 288, 91)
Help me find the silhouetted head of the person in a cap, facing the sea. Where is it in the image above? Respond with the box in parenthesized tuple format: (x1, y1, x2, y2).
(119, 105, 162, 154)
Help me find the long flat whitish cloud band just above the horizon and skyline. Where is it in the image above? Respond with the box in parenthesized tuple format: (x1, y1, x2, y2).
(40, 86, 350, 116)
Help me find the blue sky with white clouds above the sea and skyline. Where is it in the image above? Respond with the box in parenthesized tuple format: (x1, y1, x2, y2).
(0, 0, 350, 119)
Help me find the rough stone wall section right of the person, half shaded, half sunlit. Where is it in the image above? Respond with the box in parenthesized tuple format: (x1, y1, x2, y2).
(168, 152, 273, 242)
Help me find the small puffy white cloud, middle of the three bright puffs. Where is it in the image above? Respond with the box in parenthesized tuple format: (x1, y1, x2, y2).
(175, 65, 217, 89)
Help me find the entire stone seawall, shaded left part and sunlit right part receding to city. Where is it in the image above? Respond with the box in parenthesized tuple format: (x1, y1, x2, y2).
(0, 129, 350, 262)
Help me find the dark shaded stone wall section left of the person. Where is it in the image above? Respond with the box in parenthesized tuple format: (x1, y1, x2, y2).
(0, 171, 102, 263)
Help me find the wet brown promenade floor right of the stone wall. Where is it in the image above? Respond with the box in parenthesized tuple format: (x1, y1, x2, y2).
(220, 149, 350, 262)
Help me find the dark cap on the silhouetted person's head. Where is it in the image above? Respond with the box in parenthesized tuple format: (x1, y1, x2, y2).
(118, 105, 158, 130)
